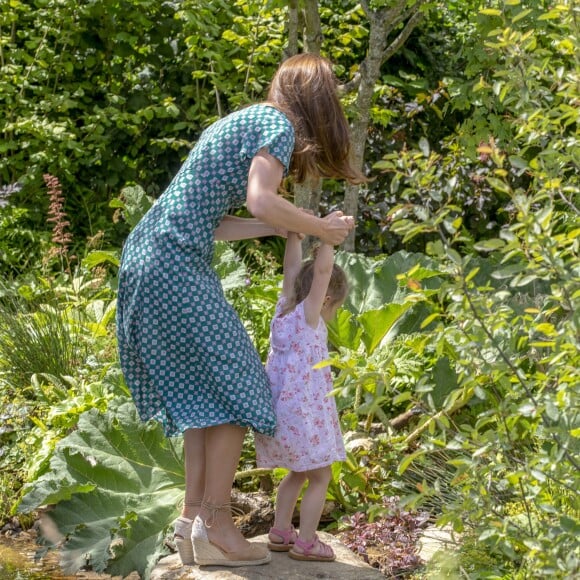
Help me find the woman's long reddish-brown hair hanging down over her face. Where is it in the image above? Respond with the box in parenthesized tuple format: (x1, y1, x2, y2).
(267, 53, 366, 183)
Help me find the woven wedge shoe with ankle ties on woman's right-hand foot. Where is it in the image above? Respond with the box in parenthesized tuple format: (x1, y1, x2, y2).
(191, 503, 272, 566)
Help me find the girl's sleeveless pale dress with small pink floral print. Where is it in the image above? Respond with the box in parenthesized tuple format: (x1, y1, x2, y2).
(255, 296, 346, 471)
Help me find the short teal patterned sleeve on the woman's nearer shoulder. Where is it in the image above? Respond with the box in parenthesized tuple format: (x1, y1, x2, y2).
(240, 105, 294, 175)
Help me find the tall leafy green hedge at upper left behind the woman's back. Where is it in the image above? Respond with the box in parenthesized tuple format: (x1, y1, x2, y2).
(0, 0, 284, 274)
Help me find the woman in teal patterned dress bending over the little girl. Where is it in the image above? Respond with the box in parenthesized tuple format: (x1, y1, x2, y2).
(117, 54, 364, 566)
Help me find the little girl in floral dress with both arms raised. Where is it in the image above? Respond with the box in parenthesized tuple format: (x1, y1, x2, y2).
(255, 234, 348, 562)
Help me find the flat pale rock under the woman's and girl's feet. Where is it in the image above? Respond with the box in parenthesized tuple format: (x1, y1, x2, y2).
(151, 532, 384, 580)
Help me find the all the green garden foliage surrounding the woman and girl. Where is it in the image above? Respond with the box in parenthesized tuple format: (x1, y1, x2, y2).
(0, 0, 580, 579)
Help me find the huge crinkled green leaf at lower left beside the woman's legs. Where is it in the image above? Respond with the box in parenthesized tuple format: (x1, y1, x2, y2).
(19, 400, 184, 577)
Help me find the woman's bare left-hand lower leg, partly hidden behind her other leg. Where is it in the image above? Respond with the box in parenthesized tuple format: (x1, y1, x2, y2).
(181, 429, 206, 520)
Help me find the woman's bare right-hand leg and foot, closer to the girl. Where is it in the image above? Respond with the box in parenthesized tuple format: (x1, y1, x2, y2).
(200, 425, 248, 552)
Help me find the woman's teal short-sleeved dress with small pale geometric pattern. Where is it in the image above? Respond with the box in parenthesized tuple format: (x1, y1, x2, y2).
(117, 105, 294, 436)
